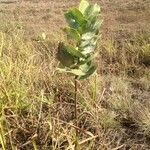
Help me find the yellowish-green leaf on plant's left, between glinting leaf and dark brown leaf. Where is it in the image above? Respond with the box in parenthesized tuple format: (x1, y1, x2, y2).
(63, 27, 80, 41)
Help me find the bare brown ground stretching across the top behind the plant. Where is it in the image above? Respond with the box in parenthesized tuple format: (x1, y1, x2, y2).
(0, 0, 150, 37)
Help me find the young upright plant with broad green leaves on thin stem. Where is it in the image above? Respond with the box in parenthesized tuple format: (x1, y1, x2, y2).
(57, 0, 102, 148)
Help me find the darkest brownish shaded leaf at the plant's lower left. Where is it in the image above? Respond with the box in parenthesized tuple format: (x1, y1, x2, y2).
(57, 43, 75, 67)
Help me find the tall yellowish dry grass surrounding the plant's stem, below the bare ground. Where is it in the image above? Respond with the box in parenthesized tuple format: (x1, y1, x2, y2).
(0, 22, 150, 150)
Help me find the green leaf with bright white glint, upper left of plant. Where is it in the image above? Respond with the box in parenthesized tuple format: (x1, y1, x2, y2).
(65, 8, 87, 30)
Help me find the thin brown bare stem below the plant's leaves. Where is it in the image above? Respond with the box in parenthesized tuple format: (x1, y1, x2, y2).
(74, 76, 78, 150)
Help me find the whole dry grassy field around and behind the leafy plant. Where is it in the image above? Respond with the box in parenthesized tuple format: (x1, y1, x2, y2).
(0, 0, 150, 150)
